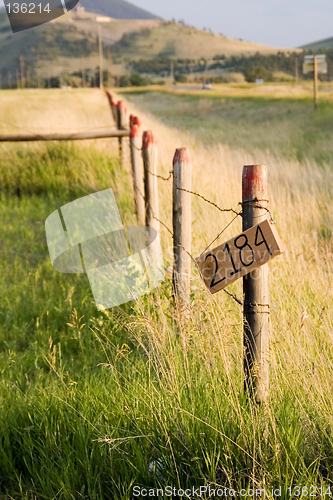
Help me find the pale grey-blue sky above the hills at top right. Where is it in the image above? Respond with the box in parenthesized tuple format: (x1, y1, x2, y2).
(0, 0, 333, 47)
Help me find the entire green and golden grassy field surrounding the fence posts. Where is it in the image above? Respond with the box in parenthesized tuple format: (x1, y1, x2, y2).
(0, 87, 333, 500)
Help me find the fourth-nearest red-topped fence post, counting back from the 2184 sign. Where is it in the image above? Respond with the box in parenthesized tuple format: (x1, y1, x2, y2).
(130, 116, 146, 226)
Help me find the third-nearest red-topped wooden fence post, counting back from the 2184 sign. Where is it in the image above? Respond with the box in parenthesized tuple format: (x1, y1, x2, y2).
(142, 131, 160, 233)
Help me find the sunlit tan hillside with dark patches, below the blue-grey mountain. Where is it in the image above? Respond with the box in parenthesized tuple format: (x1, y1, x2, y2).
(0, 8, 290, 85)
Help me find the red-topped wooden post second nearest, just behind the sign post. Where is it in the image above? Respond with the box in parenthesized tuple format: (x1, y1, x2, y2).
(173, 148, 192, 308)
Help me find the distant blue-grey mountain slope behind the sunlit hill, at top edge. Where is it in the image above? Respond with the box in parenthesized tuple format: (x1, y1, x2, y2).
(80, 0, 159, 19)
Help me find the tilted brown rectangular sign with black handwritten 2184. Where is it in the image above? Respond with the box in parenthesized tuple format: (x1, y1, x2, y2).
(196, 220, 285, 293)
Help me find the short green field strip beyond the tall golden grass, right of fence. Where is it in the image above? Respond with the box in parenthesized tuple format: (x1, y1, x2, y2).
(120, 84, 333, 165)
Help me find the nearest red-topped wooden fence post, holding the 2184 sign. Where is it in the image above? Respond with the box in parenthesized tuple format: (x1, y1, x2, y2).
(242, 165, 269, 403)
